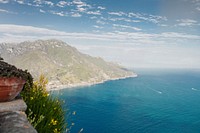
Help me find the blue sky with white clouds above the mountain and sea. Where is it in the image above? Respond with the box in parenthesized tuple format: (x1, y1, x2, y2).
(0, 0, 200, 68)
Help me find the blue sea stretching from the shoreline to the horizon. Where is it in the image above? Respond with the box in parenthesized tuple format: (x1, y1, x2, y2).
(55, 69, 200, 133)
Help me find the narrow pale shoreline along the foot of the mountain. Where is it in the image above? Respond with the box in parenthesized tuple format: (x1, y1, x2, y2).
(47, 73, 138, 92)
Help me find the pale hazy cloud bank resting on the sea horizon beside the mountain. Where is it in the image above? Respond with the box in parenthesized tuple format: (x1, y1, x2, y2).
(76, 44, 200, 68)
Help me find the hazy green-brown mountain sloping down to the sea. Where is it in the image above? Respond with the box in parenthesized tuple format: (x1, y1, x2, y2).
(0, 40, 136, 88)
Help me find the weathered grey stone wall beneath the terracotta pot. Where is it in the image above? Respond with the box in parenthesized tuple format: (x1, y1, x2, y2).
(0, 98, 37, 133)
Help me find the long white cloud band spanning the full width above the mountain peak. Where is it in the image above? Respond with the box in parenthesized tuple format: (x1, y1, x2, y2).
(0, 24, 200, 45)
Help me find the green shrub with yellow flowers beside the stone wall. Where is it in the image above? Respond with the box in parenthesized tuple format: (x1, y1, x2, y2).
(21, 76, 67, 133)
